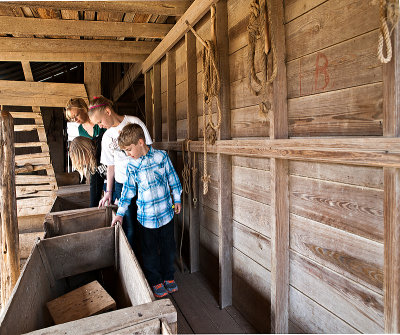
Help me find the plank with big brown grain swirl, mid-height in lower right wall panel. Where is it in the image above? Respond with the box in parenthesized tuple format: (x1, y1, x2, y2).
(290, 214, 383, 295)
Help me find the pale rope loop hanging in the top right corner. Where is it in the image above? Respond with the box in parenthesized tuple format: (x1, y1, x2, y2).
(378, 0, 399, 64)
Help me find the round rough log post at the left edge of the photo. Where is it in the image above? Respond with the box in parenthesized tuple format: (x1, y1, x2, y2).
(0, 111, 19, 308)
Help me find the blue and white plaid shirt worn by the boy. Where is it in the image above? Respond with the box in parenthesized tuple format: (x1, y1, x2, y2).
(117, 147, 182, 228)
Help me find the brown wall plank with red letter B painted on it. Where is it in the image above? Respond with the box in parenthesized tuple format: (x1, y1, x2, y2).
(287, 29, 382, 98)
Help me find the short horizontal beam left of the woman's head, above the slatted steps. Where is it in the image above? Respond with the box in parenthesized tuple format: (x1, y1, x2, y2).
(0, 80, 87, 107)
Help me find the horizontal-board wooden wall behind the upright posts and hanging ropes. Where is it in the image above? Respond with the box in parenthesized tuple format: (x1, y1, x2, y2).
(152, 0, 390, 333)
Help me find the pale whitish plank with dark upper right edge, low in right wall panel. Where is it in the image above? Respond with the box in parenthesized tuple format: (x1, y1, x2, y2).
(290, 252, 384, 333)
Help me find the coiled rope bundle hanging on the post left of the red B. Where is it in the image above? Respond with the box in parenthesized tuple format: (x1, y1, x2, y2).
(247, 0, 278, 118)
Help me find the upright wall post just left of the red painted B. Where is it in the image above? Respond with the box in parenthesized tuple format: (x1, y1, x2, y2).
(265, 0, 289, 333)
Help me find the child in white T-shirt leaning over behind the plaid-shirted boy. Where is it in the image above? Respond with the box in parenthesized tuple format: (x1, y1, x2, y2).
(88, 96, 152, 251)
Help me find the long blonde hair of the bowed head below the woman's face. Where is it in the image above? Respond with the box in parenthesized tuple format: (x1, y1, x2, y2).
(69, 136, 97, 179)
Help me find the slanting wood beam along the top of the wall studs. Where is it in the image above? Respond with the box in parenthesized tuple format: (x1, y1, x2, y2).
(143, 0, 218, 73)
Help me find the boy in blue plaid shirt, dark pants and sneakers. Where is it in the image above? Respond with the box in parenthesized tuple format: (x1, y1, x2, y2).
(112, 124, 182, 298)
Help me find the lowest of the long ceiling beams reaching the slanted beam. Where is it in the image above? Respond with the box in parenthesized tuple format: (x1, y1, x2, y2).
(0, 37, 158, 62)
